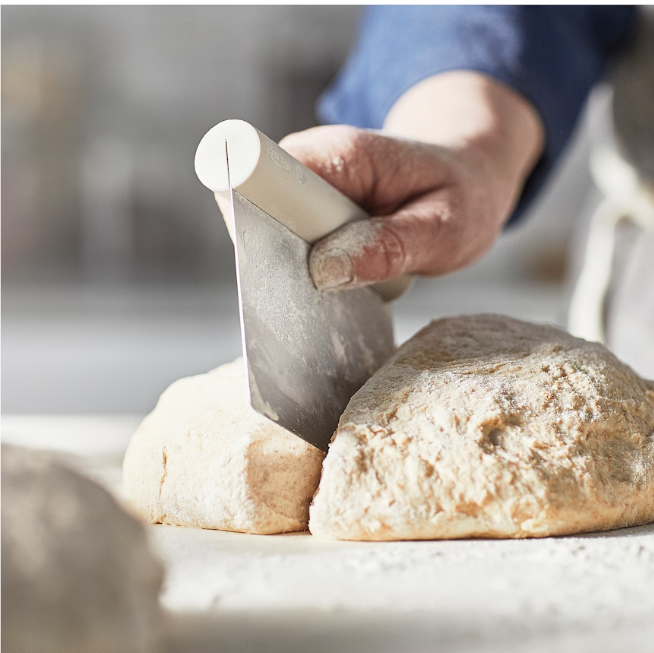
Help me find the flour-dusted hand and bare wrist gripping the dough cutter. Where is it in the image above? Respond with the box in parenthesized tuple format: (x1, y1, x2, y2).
(280, 72, 543, 289)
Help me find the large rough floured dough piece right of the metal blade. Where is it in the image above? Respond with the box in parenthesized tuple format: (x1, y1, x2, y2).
(309, 315, 654, 540)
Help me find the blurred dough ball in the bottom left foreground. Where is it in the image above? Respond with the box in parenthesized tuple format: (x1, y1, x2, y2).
(2, 445, 163, 653)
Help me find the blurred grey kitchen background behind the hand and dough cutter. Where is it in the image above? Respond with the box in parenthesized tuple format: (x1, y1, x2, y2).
(2, 6, 606, 413)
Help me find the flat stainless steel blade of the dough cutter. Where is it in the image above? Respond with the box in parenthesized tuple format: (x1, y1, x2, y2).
(232, 191, 394, 451)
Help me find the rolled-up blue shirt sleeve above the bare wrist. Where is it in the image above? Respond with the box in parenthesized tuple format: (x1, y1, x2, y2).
(318, 5, 636, 222)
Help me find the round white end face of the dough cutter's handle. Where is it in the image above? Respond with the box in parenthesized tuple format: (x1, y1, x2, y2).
(195, 120, 261, 193)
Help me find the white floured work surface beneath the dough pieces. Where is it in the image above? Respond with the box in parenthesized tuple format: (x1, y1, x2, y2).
(2, 416, 654, 653)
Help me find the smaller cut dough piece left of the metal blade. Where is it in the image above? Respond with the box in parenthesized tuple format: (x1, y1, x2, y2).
(123, 359, 324, 534)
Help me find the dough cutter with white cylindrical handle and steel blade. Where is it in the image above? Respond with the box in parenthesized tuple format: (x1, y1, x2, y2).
(195, 120, 410, 451)
